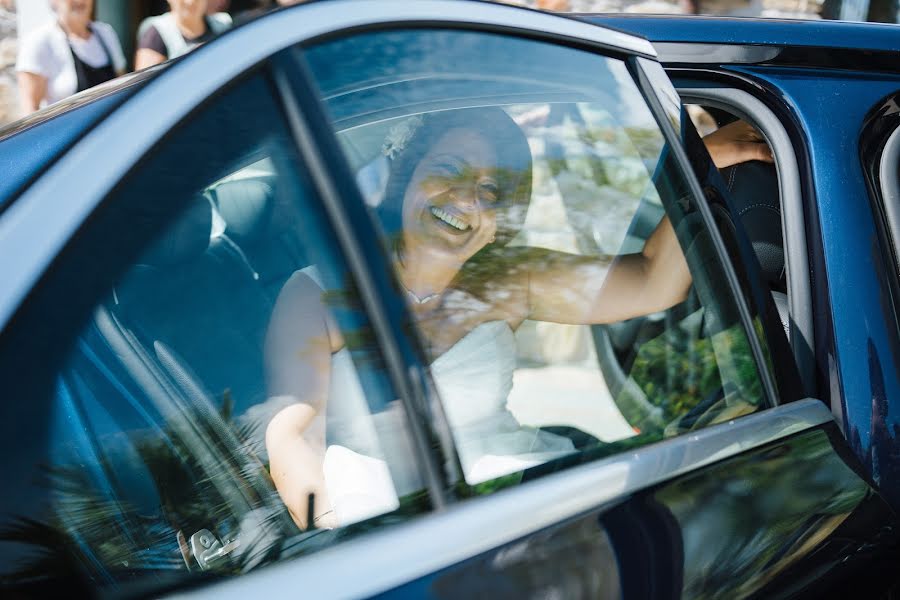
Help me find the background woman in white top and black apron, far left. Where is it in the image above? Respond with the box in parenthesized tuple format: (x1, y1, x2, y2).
(16, 0, 125, 112)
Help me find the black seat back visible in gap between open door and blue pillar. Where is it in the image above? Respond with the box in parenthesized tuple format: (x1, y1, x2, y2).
(722, 161, 785, 291)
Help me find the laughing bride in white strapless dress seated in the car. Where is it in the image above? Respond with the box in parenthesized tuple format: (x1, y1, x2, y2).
(265, 108, 771, 529)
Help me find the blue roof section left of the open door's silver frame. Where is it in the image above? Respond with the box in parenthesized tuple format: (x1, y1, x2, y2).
(0, 69, 162, 211)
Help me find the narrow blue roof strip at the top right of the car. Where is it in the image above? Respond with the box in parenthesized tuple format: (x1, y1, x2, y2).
(573, 14, 900, 52)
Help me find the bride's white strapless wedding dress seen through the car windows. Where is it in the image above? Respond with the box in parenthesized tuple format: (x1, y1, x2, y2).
(256, 267, 574, 525)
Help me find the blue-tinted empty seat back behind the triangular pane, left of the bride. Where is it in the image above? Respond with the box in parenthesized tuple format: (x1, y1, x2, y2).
(110, 195, 273, 422)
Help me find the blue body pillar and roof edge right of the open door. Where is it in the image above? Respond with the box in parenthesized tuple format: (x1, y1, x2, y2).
(594, 17, 900, 506)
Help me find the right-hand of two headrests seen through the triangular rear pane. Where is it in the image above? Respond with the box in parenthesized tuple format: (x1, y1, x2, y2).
(213, 179, 275, 246)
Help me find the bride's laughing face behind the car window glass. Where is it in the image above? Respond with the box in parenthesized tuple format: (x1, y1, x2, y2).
(403, 128, 500, 261)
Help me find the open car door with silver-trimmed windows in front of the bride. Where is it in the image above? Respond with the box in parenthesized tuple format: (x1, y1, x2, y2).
(2, 1, 893, 597)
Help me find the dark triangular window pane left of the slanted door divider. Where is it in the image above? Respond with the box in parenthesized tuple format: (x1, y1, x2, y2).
(0, 70, 428, 591)
